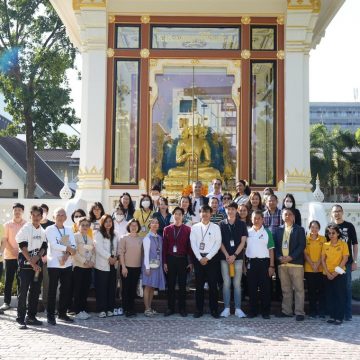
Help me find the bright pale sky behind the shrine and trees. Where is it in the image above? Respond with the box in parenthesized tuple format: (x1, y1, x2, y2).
(0, 0, 360, 122)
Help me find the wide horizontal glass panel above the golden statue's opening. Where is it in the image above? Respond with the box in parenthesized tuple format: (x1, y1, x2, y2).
(152, 26, 240, 50)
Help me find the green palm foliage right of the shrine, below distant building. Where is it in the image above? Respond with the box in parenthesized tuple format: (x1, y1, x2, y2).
(310, 124, 358, 194)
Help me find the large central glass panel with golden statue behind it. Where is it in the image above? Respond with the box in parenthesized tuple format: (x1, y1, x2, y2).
(151, 66, 240, 193)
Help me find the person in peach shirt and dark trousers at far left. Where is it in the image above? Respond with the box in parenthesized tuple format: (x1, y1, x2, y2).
(0, 203, 26, 311)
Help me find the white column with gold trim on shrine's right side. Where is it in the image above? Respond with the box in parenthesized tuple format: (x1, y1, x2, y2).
(284, 10, 318, 202)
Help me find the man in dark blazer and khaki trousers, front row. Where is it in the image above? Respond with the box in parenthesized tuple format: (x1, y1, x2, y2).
(275, 209, 306, 321)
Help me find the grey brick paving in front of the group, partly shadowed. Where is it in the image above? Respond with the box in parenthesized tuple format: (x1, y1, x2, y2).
(0, 310, 360, 360)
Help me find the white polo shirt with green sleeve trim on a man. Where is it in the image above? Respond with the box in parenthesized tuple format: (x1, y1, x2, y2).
(245, 226, 274, 259)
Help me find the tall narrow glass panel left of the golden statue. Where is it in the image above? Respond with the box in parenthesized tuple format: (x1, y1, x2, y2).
(113, 60, 139, 184)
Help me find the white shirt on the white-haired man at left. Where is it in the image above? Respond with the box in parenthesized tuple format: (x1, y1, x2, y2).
(45, 224, 76, 269)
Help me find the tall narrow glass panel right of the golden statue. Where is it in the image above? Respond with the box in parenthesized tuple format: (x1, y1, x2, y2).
(251, 62, 275, 185)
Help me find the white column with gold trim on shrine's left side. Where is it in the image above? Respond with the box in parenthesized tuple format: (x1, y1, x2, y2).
(76, 7, 107, 203)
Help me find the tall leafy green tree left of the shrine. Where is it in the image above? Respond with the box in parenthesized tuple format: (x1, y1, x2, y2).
(0, 0, 79, 198)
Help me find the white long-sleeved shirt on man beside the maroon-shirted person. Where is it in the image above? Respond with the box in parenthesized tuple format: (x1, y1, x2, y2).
(190, 222, 221, 261)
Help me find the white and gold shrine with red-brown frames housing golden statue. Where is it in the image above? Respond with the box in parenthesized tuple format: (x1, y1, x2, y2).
(51, 0, 343, 210)
